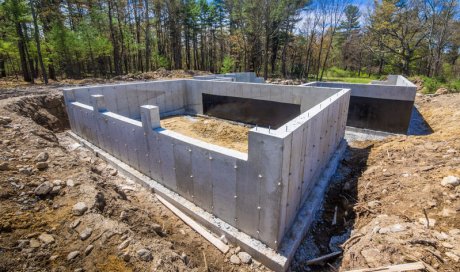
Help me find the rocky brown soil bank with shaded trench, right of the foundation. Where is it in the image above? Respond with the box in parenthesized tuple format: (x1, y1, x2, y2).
(293, 94, 460, 271)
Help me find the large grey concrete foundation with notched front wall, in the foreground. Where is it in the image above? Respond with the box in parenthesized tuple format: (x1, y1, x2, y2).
(64, 80, 350, 270)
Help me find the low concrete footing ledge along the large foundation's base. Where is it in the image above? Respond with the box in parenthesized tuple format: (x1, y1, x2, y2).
(67, 132, 347, 271)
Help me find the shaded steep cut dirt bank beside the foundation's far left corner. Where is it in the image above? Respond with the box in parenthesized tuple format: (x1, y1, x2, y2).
(6, 94, 70, 132)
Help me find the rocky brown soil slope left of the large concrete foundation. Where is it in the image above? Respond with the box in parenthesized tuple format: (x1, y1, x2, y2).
(0, 82, 266, 271)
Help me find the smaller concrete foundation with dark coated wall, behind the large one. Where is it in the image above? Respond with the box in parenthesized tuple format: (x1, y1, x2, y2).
(303, 75, 417, 134)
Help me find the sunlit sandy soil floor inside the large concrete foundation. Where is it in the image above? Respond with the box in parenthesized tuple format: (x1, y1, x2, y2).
(161, 116, 250, 153)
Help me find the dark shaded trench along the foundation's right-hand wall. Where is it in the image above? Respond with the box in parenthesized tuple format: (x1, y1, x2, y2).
(291, 145, 373, 271)
